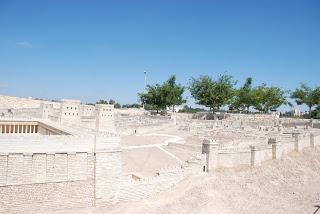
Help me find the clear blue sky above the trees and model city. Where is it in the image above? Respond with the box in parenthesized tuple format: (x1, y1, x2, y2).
(0, 0, 320, 108)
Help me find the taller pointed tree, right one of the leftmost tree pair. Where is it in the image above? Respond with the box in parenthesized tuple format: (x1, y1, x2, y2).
(161, 75, 186, 112)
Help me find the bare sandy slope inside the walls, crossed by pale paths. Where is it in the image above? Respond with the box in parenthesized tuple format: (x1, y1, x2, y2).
(121, 127, 202, 177)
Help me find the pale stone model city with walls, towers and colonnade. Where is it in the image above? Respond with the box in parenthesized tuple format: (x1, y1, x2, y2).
(0, 96, 320, 213)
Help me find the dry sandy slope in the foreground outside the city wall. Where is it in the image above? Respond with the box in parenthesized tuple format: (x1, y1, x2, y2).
(52, 148, 320, 214)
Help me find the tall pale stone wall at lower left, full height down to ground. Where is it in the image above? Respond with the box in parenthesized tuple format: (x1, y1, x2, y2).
(0, 153, 94, 213)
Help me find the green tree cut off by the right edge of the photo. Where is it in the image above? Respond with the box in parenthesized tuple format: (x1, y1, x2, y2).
(291, 83, 320, 114)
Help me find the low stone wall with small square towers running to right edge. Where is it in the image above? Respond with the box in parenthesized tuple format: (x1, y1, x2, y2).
(201, 133, 320, 171)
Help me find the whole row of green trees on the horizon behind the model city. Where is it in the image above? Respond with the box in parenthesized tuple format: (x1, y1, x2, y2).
(138, 74, 320, 118)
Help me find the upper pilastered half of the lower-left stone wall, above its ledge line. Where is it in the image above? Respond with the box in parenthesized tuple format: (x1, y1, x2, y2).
(0, 153, 93, 186)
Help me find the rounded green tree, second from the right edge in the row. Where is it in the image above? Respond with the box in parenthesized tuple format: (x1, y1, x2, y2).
(251, 84, 290, 113)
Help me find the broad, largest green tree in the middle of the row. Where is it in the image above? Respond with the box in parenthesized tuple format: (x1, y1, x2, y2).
(189, 75, 236, 113)
